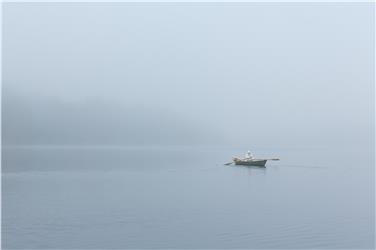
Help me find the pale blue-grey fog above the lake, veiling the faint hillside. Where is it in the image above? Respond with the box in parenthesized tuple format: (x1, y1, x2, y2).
(3, 3, 375, 147)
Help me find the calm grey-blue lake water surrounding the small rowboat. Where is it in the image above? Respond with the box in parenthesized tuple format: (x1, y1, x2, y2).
(2, 147, 375, 249)
